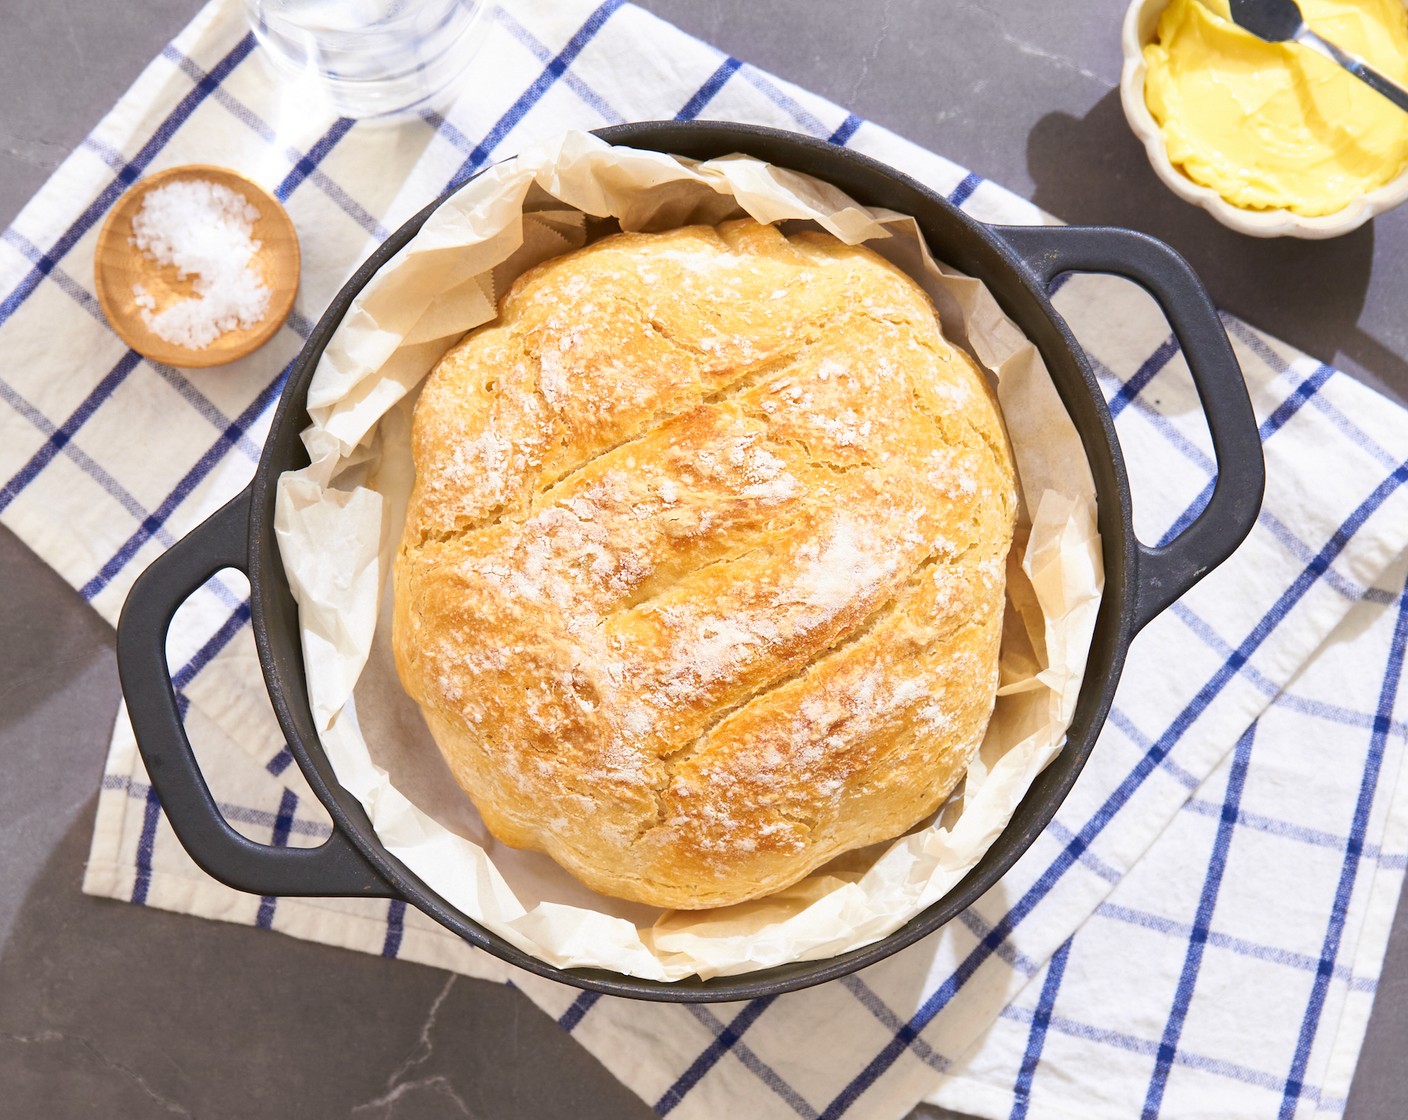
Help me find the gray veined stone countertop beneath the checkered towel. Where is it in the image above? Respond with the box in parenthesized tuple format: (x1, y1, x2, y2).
(0, 0, 1408, 1120)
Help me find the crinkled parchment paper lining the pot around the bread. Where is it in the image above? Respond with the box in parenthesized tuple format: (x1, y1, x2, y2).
(276, 132, 1102, 981)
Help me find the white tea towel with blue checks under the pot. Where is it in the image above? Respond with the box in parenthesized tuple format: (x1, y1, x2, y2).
(0, 0, 1408, 1120)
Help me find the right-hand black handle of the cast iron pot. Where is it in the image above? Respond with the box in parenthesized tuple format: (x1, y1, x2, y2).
(995, 225, 1266, 634)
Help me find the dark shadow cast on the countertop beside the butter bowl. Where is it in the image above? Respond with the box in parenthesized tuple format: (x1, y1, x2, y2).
(1026, 89, 1408, 402)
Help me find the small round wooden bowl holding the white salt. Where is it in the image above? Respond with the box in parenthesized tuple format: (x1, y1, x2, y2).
(93, 163, 300, 368)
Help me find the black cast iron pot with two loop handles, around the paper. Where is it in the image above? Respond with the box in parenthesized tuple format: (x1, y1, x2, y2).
(117, 121, 1264, 1003)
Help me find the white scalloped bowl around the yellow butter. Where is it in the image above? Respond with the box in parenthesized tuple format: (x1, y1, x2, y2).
(1119, 0, 1408, 238)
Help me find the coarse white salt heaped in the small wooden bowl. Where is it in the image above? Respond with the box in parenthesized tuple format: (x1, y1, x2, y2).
(132, 179, 269, 349)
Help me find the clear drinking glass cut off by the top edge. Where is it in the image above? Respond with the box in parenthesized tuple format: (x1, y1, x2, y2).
(245, 0, 486, 118)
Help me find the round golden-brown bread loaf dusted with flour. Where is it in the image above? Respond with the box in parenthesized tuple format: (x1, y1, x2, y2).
(393, 220, 1017, 909)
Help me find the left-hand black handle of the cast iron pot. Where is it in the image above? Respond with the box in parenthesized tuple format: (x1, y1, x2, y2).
(117, 490, 396, 897)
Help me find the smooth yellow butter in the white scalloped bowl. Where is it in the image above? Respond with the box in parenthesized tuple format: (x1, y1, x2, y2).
(1145, 0, 1408, 217)
